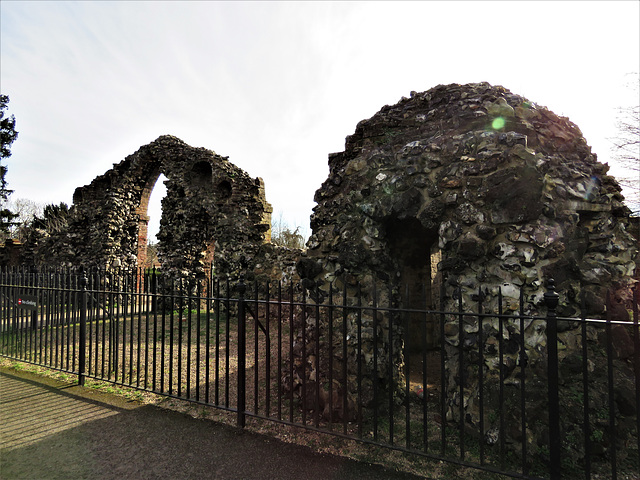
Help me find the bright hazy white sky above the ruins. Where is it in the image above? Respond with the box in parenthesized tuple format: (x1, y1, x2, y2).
(0, 0, 640, 240)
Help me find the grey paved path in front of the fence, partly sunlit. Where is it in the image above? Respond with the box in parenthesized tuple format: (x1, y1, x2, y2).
(0, 369, 418, 480)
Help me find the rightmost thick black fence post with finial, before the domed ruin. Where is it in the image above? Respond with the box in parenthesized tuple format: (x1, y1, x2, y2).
(544, 278, 561, 480)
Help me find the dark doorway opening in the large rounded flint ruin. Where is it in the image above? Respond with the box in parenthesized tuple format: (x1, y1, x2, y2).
(383, 217, 441, 354)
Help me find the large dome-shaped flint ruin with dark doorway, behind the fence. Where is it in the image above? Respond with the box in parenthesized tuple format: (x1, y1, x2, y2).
(299, 83, 637, 454)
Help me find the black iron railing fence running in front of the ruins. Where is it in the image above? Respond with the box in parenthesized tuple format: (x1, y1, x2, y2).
(0, 269, 640, 479)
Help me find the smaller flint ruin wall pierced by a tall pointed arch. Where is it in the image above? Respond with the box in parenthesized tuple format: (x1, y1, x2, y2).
(60, 136, 271, 276)
